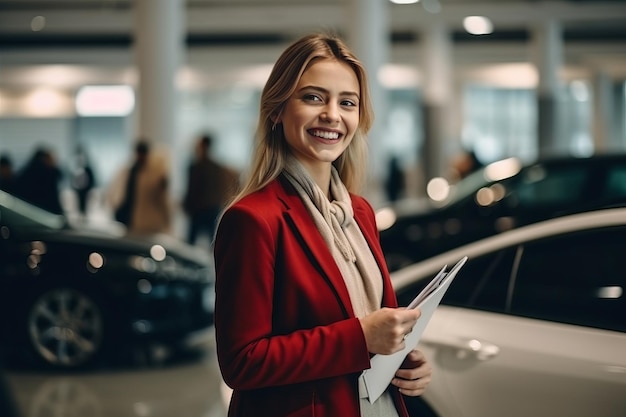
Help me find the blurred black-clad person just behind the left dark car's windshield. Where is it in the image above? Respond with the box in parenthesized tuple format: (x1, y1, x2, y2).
(16, 146, 64, 214)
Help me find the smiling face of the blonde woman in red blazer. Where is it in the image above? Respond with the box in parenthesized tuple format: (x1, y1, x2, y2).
(277, 59, 360, 173)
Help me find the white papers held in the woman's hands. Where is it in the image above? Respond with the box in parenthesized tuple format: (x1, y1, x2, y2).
(363, 256, 467, 403)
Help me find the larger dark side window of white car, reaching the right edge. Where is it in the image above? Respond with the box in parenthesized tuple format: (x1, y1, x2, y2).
(511, 227, 626, 332)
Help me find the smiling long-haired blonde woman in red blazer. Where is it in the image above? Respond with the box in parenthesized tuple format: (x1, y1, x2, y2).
(214, 35, 431, 417)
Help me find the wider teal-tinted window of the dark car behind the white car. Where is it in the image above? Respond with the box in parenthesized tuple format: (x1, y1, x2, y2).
(515, 165, 588, 207)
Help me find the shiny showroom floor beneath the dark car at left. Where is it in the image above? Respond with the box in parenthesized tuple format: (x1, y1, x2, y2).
(5, 330, 229, 417)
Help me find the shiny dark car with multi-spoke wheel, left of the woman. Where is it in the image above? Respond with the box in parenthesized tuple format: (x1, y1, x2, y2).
(0, 191, 214, 369)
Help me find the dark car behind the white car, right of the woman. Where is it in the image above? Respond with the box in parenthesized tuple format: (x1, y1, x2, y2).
(377, 154, 626, 270)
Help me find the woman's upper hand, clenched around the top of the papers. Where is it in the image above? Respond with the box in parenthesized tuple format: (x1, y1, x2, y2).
(359, 307, 421, 355)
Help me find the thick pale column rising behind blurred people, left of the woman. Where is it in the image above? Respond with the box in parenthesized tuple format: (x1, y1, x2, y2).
(134, 0, 185, 147)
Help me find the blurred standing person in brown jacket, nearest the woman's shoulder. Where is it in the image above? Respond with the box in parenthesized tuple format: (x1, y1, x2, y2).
(183, 134, 238, 244)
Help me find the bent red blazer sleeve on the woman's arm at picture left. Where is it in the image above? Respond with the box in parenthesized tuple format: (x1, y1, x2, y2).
(214, 205, 370, 390)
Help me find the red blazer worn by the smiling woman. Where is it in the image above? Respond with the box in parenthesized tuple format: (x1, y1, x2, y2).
(214, 177, 408, 417)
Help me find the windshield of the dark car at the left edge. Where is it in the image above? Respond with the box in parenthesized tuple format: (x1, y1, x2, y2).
(0, 190, 67, 230)
